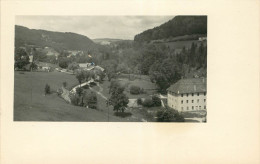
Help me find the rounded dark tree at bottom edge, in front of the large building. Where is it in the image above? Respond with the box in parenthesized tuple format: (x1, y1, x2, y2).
(156, 108, 185, 122)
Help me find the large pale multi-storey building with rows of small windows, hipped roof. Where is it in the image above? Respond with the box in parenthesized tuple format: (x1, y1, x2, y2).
(167, 78, 207, 111)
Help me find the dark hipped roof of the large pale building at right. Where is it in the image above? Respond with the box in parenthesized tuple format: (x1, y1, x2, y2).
(167, 78, 207, 94)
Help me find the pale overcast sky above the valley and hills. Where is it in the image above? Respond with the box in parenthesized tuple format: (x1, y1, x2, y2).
(15, 16, 174, 40)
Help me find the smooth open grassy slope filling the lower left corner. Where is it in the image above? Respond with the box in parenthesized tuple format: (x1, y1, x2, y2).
(14, 71, 126, 121)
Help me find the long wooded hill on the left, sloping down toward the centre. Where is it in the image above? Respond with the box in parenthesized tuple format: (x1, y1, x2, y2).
(15, 25, 101, 51)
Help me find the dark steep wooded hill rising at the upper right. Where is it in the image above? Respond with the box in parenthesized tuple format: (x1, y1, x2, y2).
(134, 16, 207, 42)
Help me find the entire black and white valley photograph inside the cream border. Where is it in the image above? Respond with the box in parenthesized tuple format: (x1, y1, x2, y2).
(13, 15, 207, 123)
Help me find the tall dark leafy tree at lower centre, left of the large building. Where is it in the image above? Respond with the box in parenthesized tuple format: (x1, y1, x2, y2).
(109, 81, 129, 113)
